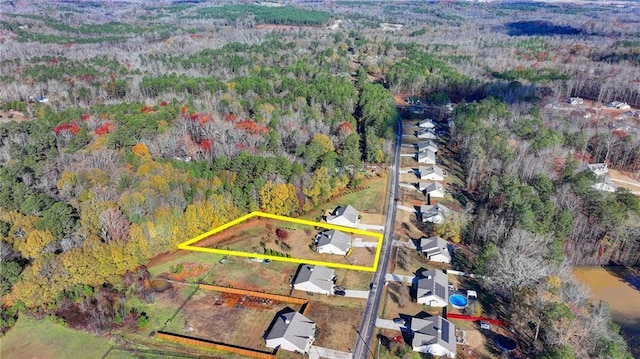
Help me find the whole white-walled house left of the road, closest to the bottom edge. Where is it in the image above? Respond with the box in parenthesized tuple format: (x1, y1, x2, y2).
(264, 307, 316, 354)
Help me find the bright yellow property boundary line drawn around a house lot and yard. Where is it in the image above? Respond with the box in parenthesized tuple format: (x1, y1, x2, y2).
(178, 211, 384, 272)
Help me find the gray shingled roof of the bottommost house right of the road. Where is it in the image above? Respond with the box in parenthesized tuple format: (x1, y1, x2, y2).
(411, 315, 456, 353)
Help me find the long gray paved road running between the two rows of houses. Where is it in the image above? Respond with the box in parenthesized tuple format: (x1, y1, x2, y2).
(353, 119, 402, 359)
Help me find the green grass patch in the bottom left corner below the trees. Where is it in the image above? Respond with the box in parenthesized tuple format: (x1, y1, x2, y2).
(0, 316, 113, 359)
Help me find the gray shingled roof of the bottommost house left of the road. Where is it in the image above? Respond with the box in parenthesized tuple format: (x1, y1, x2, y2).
(265, 308, 316, 352)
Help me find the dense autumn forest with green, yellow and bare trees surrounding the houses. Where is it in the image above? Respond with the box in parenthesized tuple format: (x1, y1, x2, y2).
(0, 1, 640, 358)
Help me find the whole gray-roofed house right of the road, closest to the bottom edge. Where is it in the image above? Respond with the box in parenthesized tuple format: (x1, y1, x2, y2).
(411, 315, 457, 358)
